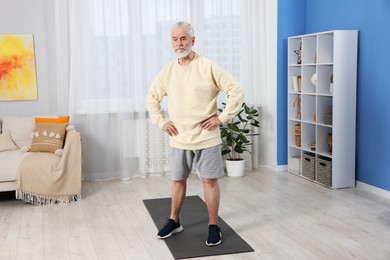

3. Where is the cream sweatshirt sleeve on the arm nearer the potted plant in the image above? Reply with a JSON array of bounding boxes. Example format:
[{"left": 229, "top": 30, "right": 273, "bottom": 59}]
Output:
[{"left": 212, "top": 64, "right": 245, "bottom": 124}]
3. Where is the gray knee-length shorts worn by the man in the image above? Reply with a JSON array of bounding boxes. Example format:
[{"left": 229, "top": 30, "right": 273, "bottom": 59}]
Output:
[{"left": 171, "top": 145, "right": 225, "bottom": 181}]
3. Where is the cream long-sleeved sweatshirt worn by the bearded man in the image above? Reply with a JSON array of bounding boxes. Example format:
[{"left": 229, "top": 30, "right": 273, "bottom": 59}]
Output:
[{"left": 146, "top": 54, "right": 244, "bottom": 150}]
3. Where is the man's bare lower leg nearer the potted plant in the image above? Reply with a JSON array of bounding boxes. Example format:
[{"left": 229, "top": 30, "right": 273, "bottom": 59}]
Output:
[{"left": 202, "top": 179, "right": 221, "bottom": 225}]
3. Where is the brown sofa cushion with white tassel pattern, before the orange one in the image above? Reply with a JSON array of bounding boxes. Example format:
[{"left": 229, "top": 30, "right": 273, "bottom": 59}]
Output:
[{"left": 29, "top": 123, "right": 68, "bottom": 153}]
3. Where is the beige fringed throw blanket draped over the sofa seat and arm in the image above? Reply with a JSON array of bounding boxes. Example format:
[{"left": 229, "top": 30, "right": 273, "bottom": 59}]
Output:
[{"left": 16, "top": 130, "right": 81, "bottom": 205}]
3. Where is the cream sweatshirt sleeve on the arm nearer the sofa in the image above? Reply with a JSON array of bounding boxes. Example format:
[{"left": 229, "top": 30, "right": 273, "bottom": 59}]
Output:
[{"left": 146, "top": 74, "right": 168, "bottom": 129}]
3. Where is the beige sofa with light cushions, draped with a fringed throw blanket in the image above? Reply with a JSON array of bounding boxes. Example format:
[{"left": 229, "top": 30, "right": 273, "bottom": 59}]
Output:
[{"left": 0, "top": 116, "right": 81, "bottom": 204}]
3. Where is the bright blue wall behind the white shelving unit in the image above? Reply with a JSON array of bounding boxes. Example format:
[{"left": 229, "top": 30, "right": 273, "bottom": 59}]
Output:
[{"left": 278, "top": 0, "right": 390, "bottom": 191}]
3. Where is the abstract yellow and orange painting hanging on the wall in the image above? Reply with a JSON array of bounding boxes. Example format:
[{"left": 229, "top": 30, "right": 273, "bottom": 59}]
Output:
[{"left": 0, "top": 34, "right": 38, "bottom": 101}]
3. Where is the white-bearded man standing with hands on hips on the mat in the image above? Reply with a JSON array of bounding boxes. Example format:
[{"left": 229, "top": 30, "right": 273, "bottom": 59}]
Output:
[{"left": 146, "top": 22, "right": 244, "bottom": 246}]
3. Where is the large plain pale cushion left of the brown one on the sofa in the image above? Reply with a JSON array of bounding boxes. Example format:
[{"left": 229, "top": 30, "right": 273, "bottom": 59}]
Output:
[{"left": 2, "top": 116, "right": 34, "bottom": 148}]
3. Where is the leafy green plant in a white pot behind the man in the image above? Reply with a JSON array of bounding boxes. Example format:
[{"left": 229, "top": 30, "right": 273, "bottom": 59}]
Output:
[{"left": 218, "top": 103, "right": 260, "bottom": 177}]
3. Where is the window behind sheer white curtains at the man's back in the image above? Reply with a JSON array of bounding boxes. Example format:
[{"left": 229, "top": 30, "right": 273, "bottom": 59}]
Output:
[{"left": 75, "top": 0, "right": 250, "bottom": 113}]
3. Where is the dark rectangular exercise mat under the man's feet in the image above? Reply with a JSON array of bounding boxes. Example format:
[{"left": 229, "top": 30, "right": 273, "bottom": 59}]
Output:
[{"left": 143, "top": 196, "right": 254, "bottom": 259}]
